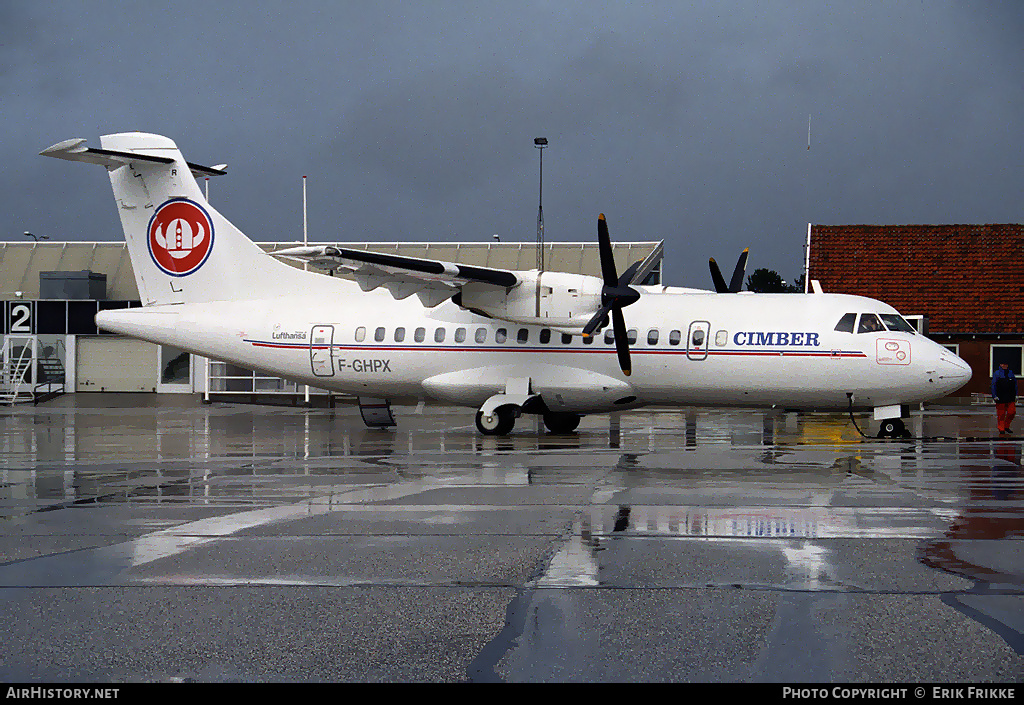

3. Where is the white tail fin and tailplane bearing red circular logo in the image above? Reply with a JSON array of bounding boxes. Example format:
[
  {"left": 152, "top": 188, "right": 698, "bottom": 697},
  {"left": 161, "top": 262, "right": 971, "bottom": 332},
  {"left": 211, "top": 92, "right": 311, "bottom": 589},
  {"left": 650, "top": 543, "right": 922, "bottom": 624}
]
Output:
[{"left": 40, "top": 132, "right": 316, "bottom": 305}]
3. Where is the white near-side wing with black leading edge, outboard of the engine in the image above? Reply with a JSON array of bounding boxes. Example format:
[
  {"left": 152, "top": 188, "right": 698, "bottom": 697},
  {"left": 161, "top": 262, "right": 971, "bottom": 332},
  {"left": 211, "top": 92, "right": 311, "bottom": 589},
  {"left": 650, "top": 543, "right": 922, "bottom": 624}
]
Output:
[{"left": 270, "top": 245, "right": 522, "bottom": 306}]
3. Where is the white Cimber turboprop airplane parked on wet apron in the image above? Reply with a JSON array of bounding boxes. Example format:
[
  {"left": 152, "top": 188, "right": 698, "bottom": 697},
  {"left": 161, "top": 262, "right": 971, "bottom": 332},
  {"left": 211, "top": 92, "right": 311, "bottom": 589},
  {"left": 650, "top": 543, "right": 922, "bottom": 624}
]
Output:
[{"left": 42, "top": 132, "right": 971, "bottom": 437}]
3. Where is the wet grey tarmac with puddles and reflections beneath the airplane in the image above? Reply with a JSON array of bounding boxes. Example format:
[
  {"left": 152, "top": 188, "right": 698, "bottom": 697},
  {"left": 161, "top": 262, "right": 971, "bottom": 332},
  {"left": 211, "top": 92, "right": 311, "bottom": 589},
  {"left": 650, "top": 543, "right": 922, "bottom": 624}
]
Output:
[{"left": 0, "top": 395, "right": 1024, "bottom": 682}]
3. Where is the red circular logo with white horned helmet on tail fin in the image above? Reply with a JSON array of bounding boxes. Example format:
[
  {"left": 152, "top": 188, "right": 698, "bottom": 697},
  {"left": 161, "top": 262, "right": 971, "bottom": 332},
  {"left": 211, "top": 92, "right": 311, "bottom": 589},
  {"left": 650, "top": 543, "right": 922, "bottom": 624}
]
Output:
[{"left": 146, "top": 199, "right": 213, "bottom": 277}]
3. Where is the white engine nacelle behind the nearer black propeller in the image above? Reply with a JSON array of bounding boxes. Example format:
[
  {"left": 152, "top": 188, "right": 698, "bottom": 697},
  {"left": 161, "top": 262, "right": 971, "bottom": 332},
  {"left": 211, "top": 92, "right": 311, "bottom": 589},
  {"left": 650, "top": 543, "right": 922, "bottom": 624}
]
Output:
[{"left": 452, "top": 269, "right": 603, "bottom": 331}]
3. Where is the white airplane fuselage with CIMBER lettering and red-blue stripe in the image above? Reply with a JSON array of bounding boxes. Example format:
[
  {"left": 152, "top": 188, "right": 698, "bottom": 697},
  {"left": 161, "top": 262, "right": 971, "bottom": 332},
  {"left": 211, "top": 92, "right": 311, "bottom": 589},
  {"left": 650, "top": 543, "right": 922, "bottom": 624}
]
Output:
[{"left": 97, "top": 282, "right": 970, "bottom": 413}]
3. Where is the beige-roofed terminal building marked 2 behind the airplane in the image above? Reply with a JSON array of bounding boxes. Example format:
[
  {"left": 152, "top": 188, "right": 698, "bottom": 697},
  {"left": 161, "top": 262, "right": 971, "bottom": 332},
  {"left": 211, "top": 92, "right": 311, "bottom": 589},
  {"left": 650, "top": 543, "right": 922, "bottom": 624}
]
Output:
[{"left": 0, "top": 241, "right": 664, "bottom": 405}]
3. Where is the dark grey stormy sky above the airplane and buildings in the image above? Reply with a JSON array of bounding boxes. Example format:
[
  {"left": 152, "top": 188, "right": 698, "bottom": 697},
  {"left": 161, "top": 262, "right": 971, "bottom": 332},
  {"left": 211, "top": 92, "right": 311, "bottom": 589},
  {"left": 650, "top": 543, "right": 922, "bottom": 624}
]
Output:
[{"left": 0, "top": 0, "right": 1024, "bottom": 287}]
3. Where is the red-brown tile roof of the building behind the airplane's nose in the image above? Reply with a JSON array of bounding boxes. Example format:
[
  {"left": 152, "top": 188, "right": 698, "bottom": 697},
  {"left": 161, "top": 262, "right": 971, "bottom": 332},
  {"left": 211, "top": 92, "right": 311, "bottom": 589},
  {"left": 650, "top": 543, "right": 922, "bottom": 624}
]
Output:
[{"left": 810, "top": 224, "right": 1024, "bottom": 333}]
